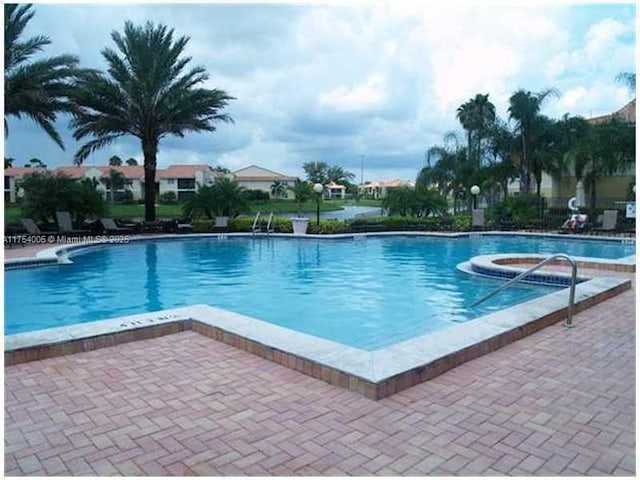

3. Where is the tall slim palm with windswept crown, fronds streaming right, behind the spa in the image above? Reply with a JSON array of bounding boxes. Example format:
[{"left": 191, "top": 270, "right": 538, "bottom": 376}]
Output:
[{"left": 509, "top": 88, "right": 558, "bottom": 193}]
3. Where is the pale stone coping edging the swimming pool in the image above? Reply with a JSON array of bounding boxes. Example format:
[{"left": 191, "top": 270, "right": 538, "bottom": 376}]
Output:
[{"left": 4, "top": 232, "right": 635, "bottom": 399}]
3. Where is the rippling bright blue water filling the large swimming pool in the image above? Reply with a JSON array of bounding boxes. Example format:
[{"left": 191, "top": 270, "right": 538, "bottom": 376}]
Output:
[{"left": 5, "top": 236, "right": 635, "bottom": 350}]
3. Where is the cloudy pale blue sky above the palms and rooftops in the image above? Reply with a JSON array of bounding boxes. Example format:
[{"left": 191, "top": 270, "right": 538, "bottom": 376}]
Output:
[{"left": 5, "top": 1, "right": 636, "bottom": 181}]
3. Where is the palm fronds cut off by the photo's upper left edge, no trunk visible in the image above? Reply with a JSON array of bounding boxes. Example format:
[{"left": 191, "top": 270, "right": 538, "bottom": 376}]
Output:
[{"left": 4, "top": 3, "right": 86, "bottom": 150}]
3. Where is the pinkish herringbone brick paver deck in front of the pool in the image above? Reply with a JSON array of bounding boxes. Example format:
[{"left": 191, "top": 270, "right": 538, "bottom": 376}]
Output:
[{"left": 5, "top": 284, "right": 635, "bottom": 475}]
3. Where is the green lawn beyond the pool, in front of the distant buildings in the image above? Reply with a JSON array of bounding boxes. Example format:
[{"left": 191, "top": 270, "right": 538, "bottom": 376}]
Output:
[{"left": 4, "top": 199, "right": 380, "bottom": 225}]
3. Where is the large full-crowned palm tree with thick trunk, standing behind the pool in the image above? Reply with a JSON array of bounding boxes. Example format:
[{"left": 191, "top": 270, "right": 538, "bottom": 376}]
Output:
[{"left": 71, "top": 22, "right": 233, "bottom": 221}]
